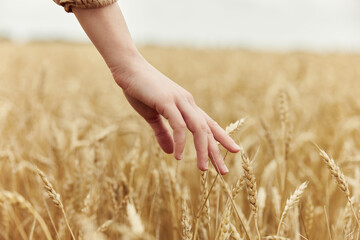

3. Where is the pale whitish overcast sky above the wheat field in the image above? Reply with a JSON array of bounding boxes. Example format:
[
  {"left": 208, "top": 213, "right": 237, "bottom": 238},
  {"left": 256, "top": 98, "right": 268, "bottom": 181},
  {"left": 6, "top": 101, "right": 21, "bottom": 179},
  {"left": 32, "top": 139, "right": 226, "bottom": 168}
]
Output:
[{"left": 0, "top": 0, "right": 360, "bottom": 52}]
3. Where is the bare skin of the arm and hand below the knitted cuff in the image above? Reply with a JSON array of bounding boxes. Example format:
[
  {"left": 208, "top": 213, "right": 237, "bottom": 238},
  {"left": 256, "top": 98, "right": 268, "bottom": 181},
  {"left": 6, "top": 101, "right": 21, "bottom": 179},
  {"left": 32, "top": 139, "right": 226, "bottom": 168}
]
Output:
[{"left": 72, "top": 1, "right": 240, "bottom": 174}]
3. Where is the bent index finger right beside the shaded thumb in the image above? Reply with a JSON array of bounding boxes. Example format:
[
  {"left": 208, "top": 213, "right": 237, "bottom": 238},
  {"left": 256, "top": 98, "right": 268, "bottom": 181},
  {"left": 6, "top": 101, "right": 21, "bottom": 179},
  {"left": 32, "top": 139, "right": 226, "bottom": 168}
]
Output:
[{"left": 163, "top": 106, "right": 186, "bottom": 160}]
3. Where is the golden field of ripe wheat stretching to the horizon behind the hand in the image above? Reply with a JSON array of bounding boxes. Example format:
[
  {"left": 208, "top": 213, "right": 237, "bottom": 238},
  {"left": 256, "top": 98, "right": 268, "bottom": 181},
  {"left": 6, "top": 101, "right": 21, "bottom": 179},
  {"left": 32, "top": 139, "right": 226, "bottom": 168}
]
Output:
[{"left": 0, "top": 41, "right": 360, "bottom": 240}]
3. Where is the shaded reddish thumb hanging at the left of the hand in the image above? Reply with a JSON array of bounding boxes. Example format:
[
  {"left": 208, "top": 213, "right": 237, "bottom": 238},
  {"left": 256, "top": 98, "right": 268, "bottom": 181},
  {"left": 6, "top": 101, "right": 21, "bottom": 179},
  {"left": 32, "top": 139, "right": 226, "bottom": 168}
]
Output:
[{"left": 146, "top": 115, "right": 174, "bottom": 153}]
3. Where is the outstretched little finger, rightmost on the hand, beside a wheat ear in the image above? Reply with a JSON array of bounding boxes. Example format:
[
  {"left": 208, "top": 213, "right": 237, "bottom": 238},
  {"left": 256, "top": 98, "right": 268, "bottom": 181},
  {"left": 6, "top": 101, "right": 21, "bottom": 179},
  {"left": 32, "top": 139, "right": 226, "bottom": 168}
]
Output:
[{"left": 199, "top": 108, "right": 240, "bottom": 153}]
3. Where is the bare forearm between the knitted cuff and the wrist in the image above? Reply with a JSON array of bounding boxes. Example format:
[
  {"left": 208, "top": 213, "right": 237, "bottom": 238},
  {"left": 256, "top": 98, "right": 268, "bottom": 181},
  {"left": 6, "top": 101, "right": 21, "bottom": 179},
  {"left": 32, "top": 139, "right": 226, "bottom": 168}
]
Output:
[{"left": 72, "top": 3, "right": 142, "bottom": 82}]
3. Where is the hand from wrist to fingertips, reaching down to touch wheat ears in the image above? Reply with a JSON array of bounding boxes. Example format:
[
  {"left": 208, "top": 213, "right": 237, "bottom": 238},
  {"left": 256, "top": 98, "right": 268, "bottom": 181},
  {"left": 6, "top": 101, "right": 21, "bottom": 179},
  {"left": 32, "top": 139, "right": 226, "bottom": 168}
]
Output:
[{"left": 111, "top": 55, "right": 239, "bottom": 174}]
